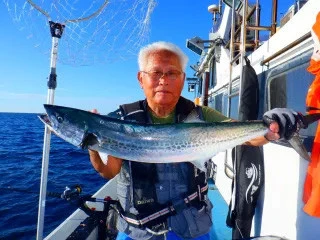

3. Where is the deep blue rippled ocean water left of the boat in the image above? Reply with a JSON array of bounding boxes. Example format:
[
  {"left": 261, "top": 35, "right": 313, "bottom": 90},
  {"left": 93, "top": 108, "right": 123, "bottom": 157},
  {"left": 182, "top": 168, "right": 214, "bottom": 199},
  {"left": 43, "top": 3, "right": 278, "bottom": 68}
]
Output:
[{"left": 0, "top": 113, "right": 106, "bottom": 240}]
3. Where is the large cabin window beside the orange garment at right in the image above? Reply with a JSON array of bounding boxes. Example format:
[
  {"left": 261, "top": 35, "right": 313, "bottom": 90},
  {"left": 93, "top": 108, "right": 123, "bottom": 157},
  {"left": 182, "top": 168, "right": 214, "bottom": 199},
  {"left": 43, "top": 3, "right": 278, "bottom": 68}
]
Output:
[{"left": 268, "top": 55, "right": 316, "bottom": 136}]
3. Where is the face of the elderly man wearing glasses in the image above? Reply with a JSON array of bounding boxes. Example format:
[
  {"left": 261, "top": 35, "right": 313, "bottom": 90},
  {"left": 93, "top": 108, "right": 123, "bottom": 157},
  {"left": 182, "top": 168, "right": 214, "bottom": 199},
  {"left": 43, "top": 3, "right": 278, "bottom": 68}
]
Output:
[{"left": 138, "top": 50, "right": 185, "bottom": 107}]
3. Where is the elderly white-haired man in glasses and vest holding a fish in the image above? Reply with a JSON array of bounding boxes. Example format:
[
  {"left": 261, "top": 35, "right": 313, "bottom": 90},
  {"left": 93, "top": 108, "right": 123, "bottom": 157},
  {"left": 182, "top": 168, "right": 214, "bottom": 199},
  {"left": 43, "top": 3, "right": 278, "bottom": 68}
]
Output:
[{"left": 89, "top": 42, "right": 296, "bottom": 239}]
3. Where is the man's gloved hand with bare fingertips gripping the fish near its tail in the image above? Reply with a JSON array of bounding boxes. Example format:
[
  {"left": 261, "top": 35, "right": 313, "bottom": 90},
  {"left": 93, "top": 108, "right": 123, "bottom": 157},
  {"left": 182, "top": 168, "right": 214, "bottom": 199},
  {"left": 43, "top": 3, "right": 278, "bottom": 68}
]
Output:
[{"left": 263, "top": 108, "right": 299, "bottom": 141}]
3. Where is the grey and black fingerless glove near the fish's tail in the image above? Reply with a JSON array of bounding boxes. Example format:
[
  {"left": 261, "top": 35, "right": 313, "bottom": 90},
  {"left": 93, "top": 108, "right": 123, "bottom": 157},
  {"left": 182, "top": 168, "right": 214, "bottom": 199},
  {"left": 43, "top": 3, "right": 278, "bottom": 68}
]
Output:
[{"left": 263, "top": 108, "right": 300, "bottom": 140}]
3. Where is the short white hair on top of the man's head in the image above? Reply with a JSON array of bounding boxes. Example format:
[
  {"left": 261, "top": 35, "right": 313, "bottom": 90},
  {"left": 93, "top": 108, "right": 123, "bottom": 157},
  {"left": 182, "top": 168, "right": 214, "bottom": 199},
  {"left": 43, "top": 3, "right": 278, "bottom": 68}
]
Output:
[{"left": 138, "top": 41, "right": 188, "bottom": 71}]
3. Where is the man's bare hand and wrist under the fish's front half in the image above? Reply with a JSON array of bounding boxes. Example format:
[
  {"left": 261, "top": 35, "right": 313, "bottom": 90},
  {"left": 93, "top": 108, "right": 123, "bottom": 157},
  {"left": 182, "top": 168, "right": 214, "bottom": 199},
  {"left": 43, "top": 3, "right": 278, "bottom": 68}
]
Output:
[{"left": 89, "top": 150, "right": 122, "bottom": 179}]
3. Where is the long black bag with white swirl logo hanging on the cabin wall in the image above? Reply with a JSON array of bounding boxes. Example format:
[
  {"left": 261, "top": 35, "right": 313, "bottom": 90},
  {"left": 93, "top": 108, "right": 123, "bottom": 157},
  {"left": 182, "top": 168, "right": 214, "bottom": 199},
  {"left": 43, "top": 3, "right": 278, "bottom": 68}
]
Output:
[{"left": 226, "top": 57, "right": 265, "bottom": 239}]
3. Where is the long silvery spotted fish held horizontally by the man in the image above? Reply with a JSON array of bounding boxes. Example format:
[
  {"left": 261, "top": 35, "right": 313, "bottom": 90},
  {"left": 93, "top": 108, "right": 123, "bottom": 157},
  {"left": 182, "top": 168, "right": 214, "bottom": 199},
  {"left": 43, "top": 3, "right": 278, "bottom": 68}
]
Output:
[{"left": 40, "top": 105, "right": 316, "bottom": 169}]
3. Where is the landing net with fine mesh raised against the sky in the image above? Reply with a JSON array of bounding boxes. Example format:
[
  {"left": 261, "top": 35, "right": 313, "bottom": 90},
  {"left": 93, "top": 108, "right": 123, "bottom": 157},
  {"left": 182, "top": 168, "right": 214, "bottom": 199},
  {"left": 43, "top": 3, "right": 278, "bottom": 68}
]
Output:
[{"left": 3, "top": 0, "right": 156, "bottom": 66}]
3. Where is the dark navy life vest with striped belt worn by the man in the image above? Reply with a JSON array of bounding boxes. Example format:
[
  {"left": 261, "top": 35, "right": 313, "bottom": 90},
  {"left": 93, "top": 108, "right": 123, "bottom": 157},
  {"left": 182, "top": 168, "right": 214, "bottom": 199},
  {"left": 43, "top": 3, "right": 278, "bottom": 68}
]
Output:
[{"left": 117, "top": 97, "right": 208, "bottom": 235}]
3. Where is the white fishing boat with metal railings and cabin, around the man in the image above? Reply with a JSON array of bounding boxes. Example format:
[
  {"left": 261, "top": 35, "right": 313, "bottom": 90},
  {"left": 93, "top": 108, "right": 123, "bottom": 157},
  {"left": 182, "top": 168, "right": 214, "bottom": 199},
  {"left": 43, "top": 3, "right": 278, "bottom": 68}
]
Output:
[{"left": 45, "top": 0, "right": 320, "bottom": 240}]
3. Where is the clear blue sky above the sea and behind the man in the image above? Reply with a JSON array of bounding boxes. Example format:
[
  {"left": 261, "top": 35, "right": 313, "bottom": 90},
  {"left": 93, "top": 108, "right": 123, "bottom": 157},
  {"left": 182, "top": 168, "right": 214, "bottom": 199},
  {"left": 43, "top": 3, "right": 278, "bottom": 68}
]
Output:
[{"left": 0, "top": 0, "right": 294, "bottom": 114}]
